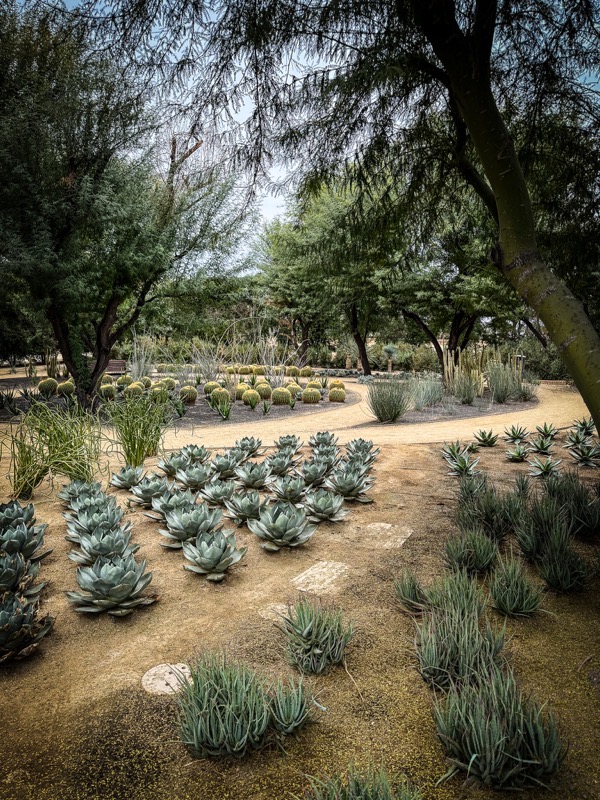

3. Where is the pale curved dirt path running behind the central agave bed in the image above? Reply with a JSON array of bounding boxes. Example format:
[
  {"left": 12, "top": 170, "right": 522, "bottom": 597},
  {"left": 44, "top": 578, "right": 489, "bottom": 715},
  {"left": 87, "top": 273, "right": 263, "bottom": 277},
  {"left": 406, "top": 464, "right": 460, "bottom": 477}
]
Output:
[{"left": 165, "top": 382, "right": 589, "bottom": 449}]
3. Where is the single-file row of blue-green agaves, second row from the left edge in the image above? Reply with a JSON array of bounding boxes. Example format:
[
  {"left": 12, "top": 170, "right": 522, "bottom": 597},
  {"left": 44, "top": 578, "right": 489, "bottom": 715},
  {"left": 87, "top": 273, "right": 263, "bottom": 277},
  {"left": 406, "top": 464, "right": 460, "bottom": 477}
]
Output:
[{"left": 58, "top": 481, "right": 157, "bottom": 617}]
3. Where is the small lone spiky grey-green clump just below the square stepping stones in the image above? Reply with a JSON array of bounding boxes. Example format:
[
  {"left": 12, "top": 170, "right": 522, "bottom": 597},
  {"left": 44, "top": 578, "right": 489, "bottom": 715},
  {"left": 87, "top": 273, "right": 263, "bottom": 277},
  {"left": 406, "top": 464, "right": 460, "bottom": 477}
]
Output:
[{"left": 281, "top": 597, "right": 354, "bottom": 675}]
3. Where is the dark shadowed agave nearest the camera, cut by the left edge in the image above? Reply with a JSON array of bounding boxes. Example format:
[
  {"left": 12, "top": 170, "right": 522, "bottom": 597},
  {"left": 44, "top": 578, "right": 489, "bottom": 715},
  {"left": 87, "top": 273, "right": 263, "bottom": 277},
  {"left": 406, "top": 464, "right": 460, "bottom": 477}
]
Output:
[{"left": 0, "top": 592, "right": 54, "bottom": 664}]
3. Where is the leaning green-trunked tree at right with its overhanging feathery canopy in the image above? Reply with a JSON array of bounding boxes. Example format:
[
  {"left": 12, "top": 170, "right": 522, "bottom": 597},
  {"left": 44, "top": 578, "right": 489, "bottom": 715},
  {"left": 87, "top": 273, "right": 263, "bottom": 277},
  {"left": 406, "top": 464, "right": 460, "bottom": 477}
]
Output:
[{"left": 96, "top": 0, "right": 600, "bottom": 426}]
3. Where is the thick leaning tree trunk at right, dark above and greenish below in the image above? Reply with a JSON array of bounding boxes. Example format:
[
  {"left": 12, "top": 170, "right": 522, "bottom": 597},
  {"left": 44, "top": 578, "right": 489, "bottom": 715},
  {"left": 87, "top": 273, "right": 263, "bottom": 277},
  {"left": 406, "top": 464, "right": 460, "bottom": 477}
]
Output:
[{"left": 413, "top": 0, "right": 600, "bottom": 430}]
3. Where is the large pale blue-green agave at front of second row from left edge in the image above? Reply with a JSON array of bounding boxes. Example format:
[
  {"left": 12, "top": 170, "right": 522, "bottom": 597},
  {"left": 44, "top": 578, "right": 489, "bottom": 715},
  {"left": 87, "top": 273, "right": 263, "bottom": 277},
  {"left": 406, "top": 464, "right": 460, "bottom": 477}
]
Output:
[{"left": 67, "top": 555, "right": 158, "bottom": 617}]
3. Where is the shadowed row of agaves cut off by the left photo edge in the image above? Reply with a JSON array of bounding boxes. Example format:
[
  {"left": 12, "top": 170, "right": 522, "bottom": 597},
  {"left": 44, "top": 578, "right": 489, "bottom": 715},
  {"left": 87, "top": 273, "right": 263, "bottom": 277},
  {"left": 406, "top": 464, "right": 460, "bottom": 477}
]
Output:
[{"left": 0, "top": 500, "right": 54, "bottom": 663}]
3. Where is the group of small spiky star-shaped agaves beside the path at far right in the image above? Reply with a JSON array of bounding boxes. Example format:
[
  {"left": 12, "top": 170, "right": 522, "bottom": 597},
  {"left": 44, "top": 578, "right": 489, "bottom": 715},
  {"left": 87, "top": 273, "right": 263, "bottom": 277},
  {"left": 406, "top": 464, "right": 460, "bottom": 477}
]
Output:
[{"left": 442, "top": 418, "right": 600, "bottom": 478}]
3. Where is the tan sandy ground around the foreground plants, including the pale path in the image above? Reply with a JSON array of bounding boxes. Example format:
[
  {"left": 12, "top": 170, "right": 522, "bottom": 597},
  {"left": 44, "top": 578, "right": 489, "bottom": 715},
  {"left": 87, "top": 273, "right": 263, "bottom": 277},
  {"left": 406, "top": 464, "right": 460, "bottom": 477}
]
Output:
[{"left": 0, "top": 386, "right": 600, "bottom": 800}]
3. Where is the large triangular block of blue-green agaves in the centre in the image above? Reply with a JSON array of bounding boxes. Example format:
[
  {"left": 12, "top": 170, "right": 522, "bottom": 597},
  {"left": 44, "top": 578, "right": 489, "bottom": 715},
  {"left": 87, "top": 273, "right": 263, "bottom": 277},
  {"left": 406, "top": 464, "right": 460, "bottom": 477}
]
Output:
[{"left": 111, "top": 432, "right": 379, "bottom": 581}]
